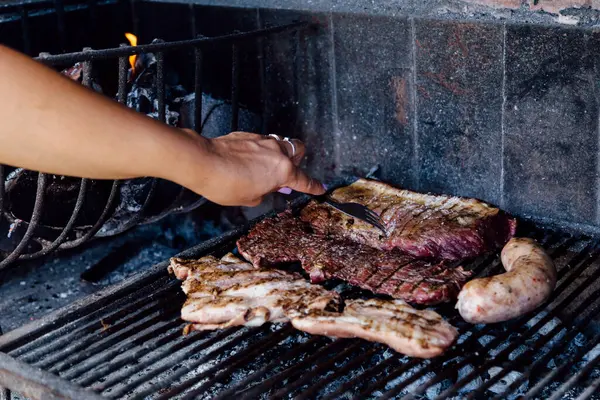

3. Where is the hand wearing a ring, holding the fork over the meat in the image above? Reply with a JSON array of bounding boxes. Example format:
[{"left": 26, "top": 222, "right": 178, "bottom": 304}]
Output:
[{"left": 180, "top": 131, "right": 325, "bottom": 206}]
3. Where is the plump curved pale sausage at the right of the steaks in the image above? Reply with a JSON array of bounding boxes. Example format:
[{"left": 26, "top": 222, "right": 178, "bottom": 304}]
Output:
[{"left": 456, "top": 238, "right": 556, "bottom": 324}]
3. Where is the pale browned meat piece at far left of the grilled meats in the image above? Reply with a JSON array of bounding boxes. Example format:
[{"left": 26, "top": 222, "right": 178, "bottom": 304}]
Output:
[{"left": 169, "top": 254, "right": 339, "bottom": 330}]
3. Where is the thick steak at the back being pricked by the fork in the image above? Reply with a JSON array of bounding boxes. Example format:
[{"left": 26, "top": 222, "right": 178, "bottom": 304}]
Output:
[{"left": 301, "top": 179, "right": 516, "bottom": 260}]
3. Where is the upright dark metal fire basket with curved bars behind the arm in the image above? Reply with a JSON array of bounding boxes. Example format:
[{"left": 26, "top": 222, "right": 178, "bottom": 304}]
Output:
[{"left": 0, "top": 0, "right": 307, "bottom": 270}]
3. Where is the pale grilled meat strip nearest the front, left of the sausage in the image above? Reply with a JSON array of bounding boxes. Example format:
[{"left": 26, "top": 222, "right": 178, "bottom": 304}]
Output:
[{"left": 292, "top": 299, "right": 458, "bottom": 358}]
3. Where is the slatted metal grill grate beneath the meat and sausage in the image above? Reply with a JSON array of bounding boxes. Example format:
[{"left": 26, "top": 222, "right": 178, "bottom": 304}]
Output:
[{"left": 0, "top": 209, "right": 600, "bottom": 399}]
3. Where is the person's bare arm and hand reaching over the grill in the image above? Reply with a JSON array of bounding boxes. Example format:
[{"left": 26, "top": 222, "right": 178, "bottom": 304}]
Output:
[{"left": 0, "top": 46, "right": 323, "bottom": 205}]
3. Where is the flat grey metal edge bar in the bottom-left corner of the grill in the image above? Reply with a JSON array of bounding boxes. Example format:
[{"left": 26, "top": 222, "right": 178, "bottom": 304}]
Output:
[{"left": 0, "top": 352, "right": 106, "bottom": 400}]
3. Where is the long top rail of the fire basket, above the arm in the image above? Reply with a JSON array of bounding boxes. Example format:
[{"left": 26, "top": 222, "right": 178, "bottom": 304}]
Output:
[{"left": 35, "top": 22, "right": 308, "bottom": 65}]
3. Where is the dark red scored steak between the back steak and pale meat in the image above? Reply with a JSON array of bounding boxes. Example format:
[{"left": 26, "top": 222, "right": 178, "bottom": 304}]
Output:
[{"left": 237, "top": 211, "right": 470, "bottom": 305}]
